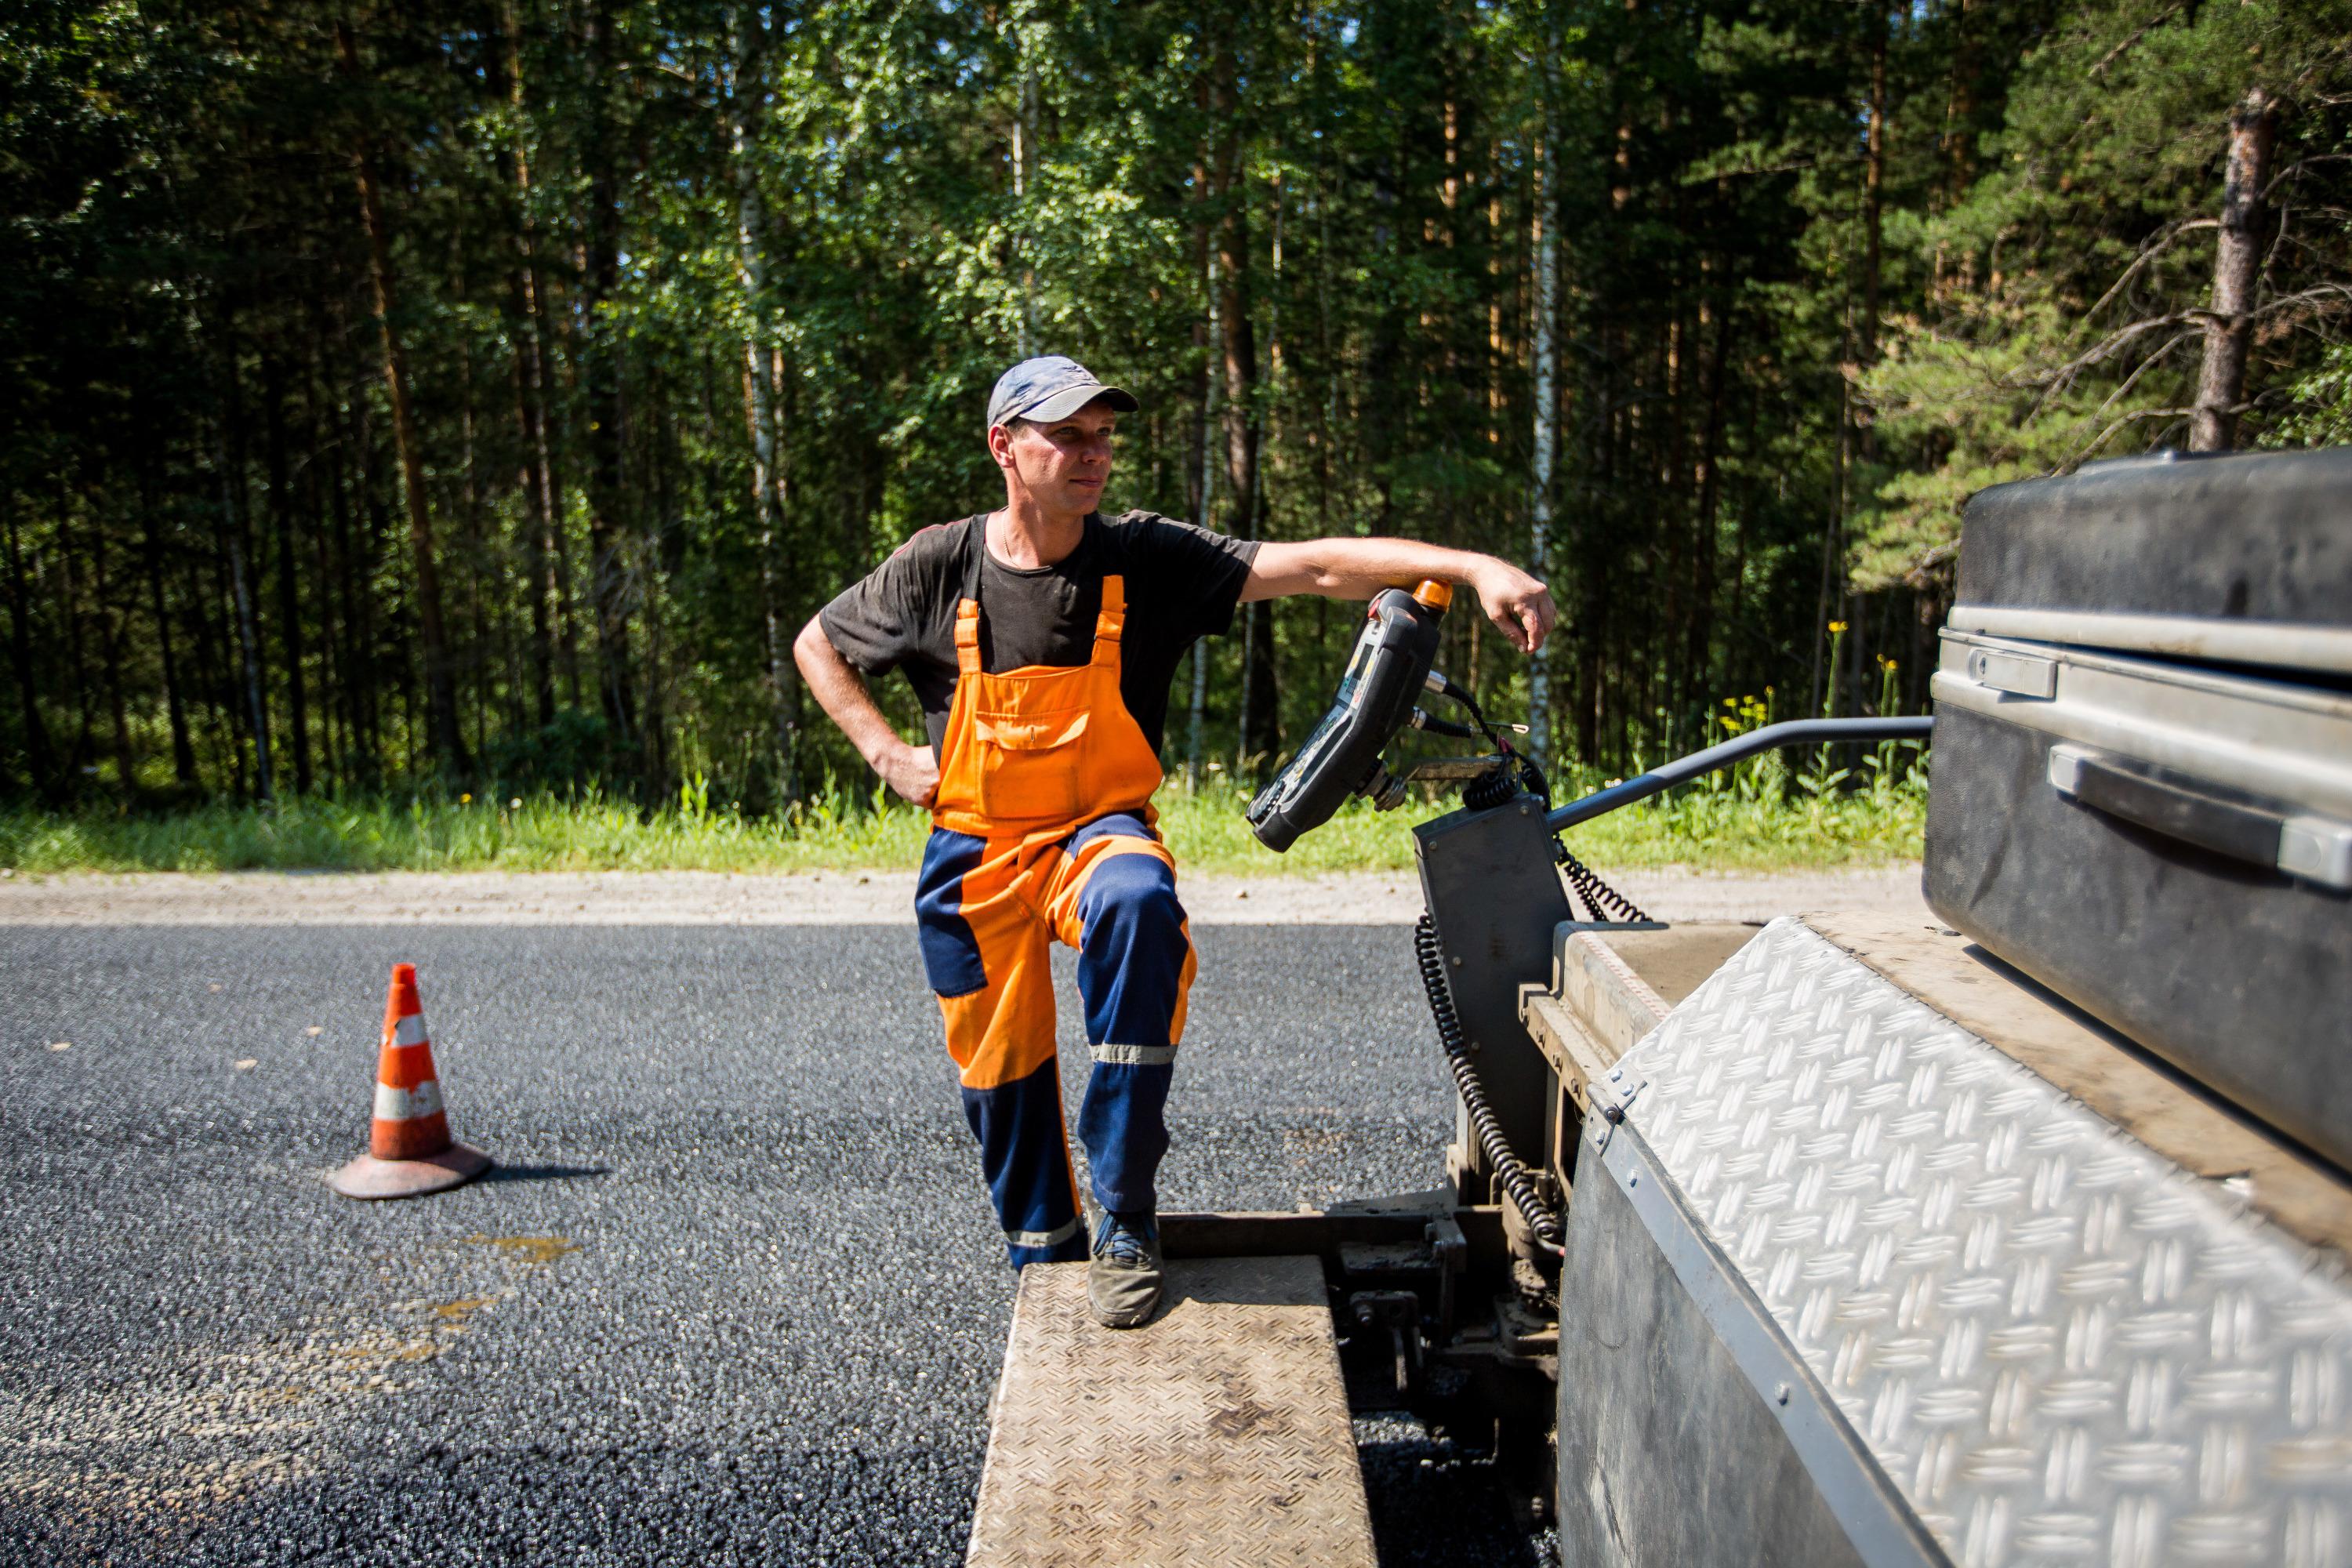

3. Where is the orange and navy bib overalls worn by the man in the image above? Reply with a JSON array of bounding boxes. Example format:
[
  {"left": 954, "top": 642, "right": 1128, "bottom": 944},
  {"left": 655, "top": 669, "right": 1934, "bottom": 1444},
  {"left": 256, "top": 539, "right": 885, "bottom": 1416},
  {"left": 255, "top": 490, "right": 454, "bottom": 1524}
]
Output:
[{"left": 915, "top": 535, "right": 1195, "bottom": 1267}]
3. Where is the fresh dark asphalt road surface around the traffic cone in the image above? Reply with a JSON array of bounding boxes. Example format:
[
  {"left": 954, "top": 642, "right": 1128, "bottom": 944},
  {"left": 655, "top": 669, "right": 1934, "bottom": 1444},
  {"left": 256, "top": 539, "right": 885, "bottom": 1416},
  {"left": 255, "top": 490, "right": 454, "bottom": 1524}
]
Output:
[{"left": 0, "top": 926, "right": 1548, "bottom": 1566}]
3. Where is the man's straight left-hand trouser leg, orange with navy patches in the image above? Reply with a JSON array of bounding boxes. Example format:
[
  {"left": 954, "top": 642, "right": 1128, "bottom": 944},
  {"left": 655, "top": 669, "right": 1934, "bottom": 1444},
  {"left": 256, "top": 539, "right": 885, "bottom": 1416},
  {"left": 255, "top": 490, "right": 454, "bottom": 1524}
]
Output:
[{"left": 915, "top": 829, "right": 1087, "bottom": 1269}]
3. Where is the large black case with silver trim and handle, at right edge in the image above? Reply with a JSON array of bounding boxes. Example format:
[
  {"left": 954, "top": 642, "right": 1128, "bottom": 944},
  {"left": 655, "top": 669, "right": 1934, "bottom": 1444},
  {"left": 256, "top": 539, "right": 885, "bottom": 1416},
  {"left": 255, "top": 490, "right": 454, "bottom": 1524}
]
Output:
[{"left": 1926, "top": 452, "right": 2352, "bottom": 1163}]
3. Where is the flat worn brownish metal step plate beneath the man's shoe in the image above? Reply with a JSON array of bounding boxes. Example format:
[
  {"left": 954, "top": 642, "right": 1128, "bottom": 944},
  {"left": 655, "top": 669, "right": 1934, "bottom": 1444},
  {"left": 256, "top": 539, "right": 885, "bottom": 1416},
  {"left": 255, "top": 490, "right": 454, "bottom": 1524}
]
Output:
[{"left": 967, "top": 1258, "right": 1374, "bottom": 1568}]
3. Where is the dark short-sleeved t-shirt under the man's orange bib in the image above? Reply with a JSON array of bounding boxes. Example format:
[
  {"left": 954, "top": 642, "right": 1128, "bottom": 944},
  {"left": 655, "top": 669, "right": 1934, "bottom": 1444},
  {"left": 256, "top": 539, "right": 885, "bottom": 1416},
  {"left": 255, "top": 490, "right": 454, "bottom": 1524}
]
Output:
[{"left": 818, "top": 513, "right": 1258, "bottom": 753}]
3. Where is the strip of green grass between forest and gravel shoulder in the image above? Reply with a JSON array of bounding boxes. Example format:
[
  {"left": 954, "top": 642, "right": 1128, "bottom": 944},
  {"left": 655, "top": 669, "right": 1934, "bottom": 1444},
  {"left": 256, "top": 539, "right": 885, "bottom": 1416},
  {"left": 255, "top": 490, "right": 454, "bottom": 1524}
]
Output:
[{"left": 0, "top": 748, "right": 1926, "bottom": 874}]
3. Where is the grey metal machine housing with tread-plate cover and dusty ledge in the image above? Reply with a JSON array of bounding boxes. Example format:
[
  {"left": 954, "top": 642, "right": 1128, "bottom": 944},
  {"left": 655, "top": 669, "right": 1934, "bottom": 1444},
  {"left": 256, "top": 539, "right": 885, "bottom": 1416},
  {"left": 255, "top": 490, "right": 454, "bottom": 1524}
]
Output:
[{"left": 1559, "top": 921, "right": 2352, "bottom": 1568}]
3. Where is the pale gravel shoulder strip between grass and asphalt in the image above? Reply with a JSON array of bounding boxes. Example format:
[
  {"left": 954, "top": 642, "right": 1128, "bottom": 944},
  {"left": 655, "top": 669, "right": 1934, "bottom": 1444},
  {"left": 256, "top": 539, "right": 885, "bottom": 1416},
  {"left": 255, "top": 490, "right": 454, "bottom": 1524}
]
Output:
[{"left": 0, "top": 862, "right": 1929, "bottom": 926}]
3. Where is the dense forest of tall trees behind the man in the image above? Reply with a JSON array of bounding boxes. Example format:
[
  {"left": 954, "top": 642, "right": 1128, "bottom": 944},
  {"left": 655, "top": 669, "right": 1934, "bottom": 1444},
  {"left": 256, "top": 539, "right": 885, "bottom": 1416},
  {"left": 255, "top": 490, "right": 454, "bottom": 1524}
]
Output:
[{"left": 0, "top": 0, "right": 2352, "bottom": 813}]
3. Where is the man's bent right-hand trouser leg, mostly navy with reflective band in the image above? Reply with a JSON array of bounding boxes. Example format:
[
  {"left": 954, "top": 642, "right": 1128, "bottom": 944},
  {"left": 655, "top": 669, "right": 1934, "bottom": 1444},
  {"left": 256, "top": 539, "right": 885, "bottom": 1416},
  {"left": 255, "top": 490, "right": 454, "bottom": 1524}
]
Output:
[{"left": 1056, "top": 818, "right": 1195, "bottom": 1210}]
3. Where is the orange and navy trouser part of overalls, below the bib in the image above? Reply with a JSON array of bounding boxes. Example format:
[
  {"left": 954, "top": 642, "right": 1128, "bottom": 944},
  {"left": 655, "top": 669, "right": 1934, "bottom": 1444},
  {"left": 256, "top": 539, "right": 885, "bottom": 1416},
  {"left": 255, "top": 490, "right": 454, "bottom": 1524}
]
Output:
[{"left": 915, "top": 811, "right": 1195, "bottom": 1269}]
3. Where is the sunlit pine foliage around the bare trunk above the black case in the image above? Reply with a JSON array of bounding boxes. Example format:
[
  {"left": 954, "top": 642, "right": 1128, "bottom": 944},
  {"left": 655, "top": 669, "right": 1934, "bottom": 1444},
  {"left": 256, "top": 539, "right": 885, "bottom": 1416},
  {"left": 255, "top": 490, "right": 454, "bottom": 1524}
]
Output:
[{"left": 1853, "top": 0, "right": 2352, "bottom": 586}]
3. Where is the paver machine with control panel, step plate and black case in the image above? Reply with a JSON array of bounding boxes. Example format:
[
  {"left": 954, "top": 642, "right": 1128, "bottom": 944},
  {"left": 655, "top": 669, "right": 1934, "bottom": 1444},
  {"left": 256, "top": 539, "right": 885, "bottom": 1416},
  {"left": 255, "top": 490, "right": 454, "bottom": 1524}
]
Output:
[{"left": 971, "top": 449, "right": 2352, "bottom": 1568}]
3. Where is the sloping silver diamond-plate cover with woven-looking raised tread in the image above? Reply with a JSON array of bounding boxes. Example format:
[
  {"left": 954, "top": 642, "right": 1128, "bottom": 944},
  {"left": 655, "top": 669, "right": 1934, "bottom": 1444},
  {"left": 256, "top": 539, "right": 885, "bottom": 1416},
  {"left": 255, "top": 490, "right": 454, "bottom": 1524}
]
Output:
[{"left": 1585, "top": 919, "right": 2352, "bottom": 1568}]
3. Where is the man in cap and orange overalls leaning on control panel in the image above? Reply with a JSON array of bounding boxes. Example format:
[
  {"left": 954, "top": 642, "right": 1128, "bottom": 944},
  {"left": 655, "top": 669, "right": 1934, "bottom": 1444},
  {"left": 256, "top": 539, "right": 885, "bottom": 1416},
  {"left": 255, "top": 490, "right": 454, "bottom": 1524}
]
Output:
[{"left": 793, "top": 355, "right": 1555, "bottom": 1328}]
